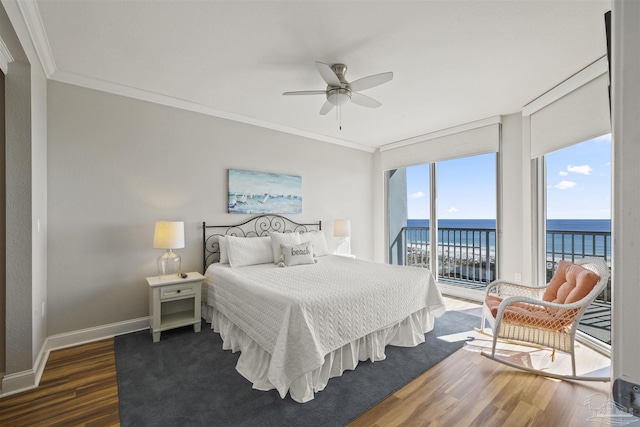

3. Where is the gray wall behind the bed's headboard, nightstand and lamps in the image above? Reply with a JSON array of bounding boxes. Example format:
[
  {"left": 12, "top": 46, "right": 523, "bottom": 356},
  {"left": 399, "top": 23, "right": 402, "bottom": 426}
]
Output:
[{"left": 48, "top": 81, "right": 374, "bottom": 335}]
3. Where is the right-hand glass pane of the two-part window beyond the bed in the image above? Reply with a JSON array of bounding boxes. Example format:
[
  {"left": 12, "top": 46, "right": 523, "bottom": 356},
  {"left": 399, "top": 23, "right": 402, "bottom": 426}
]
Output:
[{"left": 436, "top": 153, "right": 496, "bottom": 289}]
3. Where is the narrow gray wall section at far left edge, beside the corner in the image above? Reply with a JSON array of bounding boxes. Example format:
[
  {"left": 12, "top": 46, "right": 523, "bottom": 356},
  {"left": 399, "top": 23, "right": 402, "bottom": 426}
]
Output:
[{"left": 0, "top": 2, "right": 47, "bottom": 382}]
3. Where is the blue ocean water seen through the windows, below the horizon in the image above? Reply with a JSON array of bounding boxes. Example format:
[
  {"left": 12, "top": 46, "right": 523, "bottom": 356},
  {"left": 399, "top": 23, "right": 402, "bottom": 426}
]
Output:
[{"left": 407, "top": 219, "right": 611, "bottom": 261}]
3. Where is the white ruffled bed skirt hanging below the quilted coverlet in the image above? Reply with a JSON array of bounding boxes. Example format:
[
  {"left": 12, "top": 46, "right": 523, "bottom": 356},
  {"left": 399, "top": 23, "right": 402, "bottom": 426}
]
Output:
[{"left": 202, "top": 303, "right": 445, "bottom": 403}]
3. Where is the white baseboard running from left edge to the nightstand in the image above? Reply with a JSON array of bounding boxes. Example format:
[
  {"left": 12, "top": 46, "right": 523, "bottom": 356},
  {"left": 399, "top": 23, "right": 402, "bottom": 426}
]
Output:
[{"left": 0, "top": 317, "right": 149, "bottom": 397}]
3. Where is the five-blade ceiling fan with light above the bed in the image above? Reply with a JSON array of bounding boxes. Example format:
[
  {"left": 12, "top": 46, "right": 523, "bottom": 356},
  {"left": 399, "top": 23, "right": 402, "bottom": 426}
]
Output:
[{"left": 283, "top": 61, "right": 393, "bottom": 115}]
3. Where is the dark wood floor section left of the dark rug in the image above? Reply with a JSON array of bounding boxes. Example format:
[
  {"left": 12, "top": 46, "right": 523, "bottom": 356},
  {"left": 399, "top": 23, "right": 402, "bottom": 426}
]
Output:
[{"left": 0, "top": 339, "right": 120, "bottom": 427}]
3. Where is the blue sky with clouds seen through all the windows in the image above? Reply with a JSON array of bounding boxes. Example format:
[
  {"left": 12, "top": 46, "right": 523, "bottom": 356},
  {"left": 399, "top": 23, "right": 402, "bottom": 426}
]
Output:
[{"left": 407, "top": 135, "right": 611, "bottom": 219}]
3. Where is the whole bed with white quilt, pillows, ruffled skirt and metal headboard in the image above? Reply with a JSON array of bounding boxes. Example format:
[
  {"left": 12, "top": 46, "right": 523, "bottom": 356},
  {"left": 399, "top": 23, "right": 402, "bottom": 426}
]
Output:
[{"left": 202, "top": 215, "right": 445, "bottom": 403}]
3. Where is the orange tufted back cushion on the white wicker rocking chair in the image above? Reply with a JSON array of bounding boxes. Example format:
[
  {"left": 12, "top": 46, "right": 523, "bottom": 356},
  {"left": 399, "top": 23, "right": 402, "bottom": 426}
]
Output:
[{"left": 542, "top": 260, "right": 600, "bottom": 304}]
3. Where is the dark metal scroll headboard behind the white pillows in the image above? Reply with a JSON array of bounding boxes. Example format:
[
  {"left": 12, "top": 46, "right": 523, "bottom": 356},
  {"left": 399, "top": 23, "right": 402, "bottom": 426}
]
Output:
[{"left": 202, "top": 215, "right": 322, "bottom": 273}]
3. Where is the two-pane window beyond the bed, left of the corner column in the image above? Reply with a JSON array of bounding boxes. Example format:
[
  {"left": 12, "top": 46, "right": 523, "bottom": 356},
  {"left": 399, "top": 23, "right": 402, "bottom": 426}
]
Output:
[{"left": 387, "top": 153, "right": 497, "bottom": 296}]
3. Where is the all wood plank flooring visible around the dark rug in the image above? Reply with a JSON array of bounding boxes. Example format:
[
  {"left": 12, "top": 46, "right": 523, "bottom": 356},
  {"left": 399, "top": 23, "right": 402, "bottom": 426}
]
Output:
[{"left": 0, "top": 328, "right": 611, "bottom": 427}]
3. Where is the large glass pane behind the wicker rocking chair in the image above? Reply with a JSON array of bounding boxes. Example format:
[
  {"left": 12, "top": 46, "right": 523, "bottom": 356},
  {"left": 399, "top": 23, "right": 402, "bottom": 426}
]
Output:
[{"left": 545, "top": 135, "right": 611, "bottom": 344}]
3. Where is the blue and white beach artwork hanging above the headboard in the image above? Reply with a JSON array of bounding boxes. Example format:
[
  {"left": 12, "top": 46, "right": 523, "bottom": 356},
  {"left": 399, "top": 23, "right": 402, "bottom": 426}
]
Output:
[{"left": 227, "top": 169, "right": 302, "bottom": 214}]
